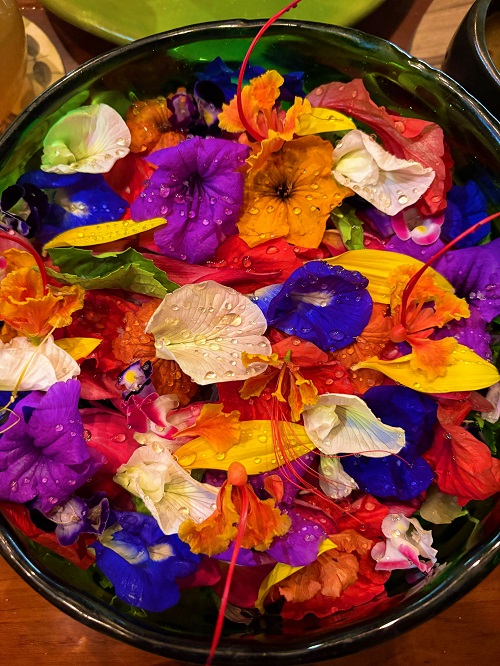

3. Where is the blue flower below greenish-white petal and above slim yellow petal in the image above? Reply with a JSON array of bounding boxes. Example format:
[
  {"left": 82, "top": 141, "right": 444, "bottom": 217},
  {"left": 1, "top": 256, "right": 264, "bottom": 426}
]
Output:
[{"left": 18, "top": 171, "right": 128, "bottom": 243}]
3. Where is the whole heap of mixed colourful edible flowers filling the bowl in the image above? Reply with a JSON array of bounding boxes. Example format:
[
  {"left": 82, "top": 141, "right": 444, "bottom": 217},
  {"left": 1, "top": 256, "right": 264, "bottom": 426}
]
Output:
[{"left": 0, "top": 2, "right": 500, "bottom": 659}]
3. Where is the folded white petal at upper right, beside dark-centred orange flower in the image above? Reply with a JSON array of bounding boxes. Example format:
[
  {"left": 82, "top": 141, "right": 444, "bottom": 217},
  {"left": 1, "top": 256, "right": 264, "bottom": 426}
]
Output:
[{"left": 332, "top": 130, "right": 435, "bottom": 215}]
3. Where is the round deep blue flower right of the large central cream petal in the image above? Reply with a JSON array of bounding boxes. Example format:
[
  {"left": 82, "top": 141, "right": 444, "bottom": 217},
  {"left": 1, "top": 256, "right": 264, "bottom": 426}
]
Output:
[{"left": 257, "top": 261, "right": 373, "bottom": 351}]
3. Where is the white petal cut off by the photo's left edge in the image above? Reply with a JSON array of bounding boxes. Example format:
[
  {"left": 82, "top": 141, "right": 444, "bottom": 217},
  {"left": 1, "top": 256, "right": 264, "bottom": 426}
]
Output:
[{"left": 0, "top": 336, "right": 80, "bottom": 391}]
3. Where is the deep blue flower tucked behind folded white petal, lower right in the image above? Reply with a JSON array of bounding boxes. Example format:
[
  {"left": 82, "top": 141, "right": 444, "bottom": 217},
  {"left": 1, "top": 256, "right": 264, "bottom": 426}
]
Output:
[{"left": 342, "top": 386, "right": 437, "bottom": 500}]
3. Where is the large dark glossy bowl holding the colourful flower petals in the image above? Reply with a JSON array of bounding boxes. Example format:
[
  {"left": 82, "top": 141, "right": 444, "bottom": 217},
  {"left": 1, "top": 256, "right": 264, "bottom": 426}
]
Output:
[{"left": 0, "top": 20, "right": 500, "bottom": 666}]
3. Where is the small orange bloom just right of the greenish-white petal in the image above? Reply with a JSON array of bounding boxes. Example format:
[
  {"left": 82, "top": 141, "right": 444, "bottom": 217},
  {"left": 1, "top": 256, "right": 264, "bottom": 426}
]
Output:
[{"left": 126, "top": 97, "right": 184, "bottom": 153}]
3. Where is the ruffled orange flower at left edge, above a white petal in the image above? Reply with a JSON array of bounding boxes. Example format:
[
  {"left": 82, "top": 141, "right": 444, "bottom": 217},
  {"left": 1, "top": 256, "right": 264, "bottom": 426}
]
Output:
[{"left": 0, "top": 249, "right": 85, "bottom": 338}]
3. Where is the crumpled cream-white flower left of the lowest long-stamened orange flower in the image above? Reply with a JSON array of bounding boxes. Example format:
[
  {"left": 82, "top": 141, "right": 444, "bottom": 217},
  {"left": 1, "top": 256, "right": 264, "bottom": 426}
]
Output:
[{"left": 115, "top": 444, "right": 219, "bottom": 534}]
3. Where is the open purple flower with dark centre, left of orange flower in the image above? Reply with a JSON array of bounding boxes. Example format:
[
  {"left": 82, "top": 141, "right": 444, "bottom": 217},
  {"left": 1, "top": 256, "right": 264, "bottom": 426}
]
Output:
[{"left": 131, "top": 137, "right": 248, "bottom": 264}]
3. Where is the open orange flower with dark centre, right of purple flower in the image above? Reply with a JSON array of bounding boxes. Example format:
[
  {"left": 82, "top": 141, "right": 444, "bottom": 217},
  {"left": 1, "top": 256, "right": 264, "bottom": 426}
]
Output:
[{"left": 238, "top": 136, "right": 352, "bottom": 248}]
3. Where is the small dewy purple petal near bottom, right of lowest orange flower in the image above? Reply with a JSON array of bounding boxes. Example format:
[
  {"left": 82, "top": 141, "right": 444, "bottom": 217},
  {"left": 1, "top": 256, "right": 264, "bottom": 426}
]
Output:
[{"left": 267, "top": 510, "right": 327, "bottom": 567}]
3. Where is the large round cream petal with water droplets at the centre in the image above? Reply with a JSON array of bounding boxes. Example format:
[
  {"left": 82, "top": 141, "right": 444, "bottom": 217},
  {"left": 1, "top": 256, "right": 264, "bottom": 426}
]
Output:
[{"left": 146, "top": 280, "right": 271, "bottom": 385}]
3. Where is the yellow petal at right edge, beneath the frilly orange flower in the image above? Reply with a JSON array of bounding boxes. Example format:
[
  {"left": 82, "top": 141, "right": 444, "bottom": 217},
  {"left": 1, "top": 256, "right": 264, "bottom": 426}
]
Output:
[{"left": 353, "top": 345, "right": 500, "bottom": 393}]
